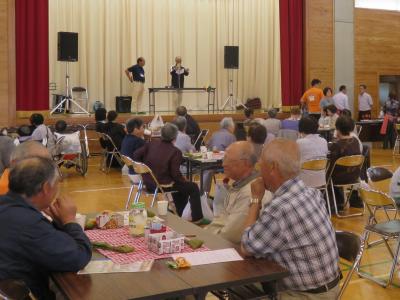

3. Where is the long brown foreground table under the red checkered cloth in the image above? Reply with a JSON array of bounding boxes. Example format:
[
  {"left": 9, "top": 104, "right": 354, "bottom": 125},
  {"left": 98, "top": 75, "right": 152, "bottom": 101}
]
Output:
[{"left": 52, "top": 214, "right": 289, "bottom": 300}]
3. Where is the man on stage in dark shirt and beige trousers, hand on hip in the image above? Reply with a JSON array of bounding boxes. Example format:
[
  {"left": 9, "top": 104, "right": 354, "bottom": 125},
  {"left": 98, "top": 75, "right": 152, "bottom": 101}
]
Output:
[{"left": 125, "top": 57, "right": 145, "bottom": 113}]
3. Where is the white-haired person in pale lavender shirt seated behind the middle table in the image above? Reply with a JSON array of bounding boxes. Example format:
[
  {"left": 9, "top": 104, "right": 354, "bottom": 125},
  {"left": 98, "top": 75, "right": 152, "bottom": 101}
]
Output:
[{"left": 203, "top": 118, "right": 236, "bottom": 193}]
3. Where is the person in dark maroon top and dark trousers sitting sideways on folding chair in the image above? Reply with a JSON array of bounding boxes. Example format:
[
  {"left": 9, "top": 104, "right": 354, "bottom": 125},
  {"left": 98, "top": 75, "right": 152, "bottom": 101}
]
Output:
[{"left": 133, "top": 123, "right": 203, "bottom": 223}]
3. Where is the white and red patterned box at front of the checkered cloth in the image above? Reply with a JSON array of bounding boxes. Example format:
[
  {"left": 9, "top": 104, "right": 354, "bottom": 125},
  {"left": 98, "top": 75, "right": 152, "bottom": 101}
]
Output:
[{"left": 147, "top": 231, "right": 185, "bottom": 255}]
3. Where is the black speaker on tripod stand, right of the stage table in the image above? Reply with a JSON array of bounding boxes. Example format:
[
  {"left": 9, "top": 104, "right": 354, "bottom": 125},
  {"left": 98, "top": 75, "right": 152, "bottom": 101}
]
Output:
[{"left": 221, "top": 46, "right": 246, "bottom": 111}]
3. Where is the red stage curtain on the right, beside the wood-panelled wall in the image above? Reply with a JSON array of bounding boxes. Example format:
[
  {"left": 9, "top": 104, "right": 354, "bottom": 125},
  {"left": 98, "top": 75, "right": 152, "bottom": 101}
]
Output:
[{"left": 279, "top": 0, "right": 303, "bottom": 106}]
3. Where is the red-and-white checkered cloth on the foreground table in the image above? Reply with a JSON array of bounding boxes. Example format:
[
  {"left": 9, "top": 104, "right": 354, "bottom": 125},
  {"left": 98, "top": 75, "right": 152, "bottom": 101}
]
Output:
[{"left": 85, "top": 227, "right": 209, "bottom": 264}]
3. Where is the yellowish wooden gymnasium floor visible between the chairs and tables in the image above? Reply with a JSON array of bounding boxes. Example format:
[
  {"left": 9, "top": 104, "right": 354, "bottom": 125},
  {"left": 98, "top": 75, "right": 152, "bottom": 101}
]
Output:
[{"left": 61, "top": 149, "right": 400, "bottom": 300}]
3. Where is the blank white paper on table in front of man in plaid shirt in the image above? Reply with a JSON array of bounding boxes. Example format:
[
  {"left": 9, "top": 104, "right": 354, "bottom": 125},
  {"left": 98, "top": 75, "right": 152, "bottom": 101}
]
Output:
[{"left": 172, "top": 248, "right": 243, "bottom": 266}]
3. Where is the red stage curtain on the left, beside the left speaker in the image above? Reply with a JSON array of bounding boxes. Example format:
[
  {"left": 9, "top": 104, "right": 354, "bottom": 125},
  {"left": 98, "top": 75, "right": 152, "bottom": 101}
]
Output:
[{"left": 15, "top": 0, "right": 49, "bottom": 111}]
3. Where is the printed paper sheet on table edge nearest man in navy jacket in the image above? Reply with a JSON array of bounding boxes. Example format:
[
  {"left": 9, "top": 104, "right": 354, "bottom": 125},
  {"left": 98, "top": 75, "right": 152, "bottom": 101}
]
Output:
[{"left": 78, "top": 260, "right": 154, "bottom": 275}]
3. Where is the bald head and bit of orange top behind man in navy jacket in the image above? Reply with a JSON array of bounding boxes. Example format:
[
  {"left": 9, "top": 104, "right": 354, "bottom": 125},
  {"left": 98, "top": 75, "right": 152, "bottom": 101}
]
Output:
[{"left": 0, "top": 141, "right": 51, "bottom": 195}]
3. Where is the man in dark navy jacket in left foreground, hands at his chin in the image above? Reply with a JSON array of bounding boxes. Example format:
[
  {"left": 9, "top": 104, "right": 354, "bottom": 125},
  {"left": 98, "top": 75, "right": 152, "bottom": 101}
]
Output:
[{"left": 0, "top": 157, "right": 92, "bottom": 299}]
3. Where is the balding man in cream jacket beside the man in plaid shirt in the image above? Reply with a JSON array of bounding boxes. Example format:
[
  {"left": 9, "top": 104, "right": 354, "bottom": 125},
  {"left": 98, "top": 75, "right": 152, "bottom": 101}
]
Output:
[{"left": 206, "top": 141, "right": 265, "bottom": 243}]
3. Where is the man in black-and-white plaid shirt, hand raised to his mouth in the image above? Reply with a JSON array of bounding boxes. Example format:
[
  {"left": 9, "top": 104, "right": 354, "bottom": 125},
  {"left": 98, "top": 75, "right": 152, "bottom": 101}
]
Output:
[{"left": 242, "top": 139, "right": 340, "bottom": 300}]
